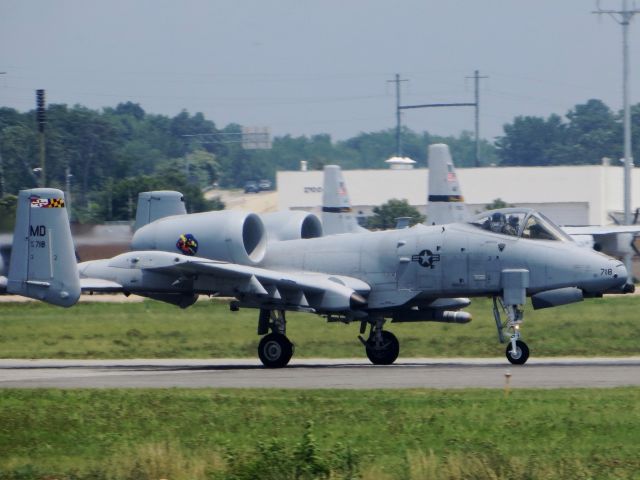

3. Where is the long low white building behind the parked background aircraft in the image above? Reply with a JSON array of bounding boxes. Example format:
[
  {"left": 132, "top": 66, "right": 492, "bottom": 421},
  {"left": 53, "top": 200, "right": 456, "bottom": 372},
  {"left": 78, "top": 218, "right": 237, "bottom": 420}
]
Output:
[{"left": 277, "top": 165, "right": 640, "bottom": 225}]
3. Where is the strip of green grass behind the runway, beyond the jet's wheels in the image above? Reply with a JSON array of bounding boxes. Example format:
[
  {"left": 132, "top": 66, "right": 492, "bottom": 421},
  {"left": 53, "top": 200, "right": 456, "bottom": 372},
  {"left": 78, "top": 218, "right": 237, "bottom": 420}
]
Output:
[{"left": 0, "top": 296, "right": 640, "bottom": 358}]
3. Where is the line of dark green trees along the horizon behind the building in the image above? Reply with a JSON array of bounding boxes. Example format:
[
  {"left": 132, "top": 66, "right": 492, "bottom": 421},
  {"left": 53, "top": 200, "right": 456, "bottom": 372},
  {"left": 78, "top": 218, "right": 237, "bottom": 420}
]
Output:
[{"left": 0, "top": 99, "right": 640, "bottom": 226}]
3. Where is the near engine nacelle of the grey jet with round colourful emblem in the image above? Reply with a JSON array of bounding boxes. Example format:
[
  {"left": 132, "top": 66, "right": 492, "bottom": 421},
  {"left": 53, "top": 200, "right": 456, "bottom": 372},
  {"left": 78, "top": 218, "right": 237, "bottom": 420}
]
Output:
[{"left": 131, "top": 210, "right": 267, "bottom": 265}]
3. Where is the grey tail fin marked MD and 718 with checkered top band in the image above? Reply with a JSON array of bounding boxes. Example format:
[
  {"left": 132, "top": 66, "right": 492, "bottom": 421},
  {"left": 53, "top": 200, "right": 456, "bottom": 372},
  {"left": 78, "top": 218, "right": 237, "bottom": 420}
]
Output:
[{"left": 7, "top": 188, "right": 80, "bottom": 307}]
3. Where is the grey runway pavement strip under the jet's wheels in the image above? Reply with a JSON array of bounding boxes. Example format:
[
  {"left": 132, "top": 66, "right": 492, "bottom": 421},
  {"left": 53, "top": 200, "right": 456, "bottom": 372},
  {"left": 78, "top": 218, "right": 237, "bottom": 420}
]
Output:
[{"left": 0, "top": 357, "right": 640, "bottom": 389}]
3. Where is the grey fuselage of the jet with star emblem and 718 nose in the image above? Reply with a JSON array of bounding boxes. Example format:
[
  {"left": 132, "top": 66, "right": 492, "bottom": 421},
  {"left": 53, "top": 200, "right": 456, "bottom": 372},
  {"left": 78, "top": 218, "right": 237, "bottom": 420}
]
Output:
[{"left": 260, "top": 224, "right": 626, "bottom": 309}]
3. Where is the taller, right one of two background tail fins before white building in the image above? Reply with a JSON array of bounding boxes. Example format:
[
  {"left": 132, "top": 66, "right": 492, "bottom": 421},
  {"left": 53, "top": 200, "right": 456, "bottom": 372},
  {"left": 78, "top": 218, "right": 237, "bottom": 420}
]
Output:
[{"left": 426, "top": 143, "right": 467, "bottom": 225}]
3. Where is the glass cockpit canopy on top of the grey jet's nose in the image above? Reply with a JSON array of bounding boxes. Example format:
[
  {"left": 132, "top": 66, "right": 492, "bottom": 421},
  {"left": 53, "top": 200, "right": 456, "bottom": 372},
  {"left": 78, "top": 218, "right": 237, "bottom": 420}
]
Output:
[{"left": 469, "top": 208, "right": 573, "bottom": 242}]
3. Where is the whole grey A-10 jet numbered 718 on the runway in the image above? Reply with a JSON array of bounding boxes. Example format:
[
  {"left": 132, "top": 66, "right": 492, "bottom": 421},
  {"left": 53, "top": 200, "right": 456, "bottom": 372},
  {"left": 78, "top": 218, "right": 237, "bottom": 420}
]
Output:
[{"left": 7, "top": 189, "right": 627, "bottom": 367}]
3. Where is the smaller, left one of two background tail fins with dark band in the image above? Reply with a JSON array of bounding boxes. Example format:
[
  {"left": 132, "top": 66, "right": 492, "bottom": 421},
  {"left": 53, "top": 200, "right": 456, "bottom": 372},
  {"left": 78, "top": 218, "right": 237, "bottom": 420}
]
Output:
[{"left": 322, "top": 165, "right": 366, "bottom": 235}]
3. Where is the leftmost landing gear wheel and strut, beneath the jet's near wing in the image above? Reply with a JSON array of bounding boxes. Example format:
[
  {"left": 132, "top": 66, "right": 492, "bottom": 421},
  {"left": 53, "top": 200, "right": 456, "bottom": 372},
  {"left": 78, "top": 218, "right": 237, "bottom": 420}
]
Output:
[{"left": 258, "top": 309, "right": 293, "bottom": 368}]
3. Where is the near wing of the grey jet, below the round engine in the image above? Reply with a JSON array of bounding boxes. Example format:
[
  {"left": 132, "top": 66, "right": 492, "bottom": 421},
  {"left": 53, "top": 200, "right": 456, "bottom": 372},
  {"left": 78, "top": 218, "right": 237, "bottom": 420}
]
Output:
[{"left": 79, "top": 251, "right": 370, "bottom": 312}]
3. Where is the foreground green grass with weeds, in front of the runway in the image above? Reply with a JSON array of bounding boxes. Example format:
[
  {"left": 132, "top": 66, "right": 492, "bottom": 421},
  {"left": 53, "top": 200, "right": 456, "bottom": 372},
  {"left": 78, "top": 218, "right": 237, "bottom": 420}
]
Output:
[{"left": 0, "top": 388, "right": 640, "bottom": 480}]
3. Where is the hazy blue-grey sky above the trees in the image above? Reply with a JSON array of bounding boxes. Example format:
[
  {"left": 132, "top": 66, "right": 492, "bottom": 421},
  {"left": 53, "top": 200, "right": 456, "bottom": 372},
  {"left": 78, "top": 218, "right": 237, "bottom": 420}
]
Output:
[{"left": 0, "top": 0, "right": 640, "bottom": 140}]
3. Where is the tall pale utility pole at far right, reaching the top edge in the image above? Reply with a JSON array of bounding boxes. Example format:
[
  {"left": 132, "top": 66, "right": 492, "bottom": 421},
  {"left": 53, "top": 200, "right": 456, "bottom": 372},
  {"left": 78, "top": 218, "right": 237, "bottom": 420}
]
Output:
[{"left": 591, "top": 0, "right": 640, "bottom": 283}]
